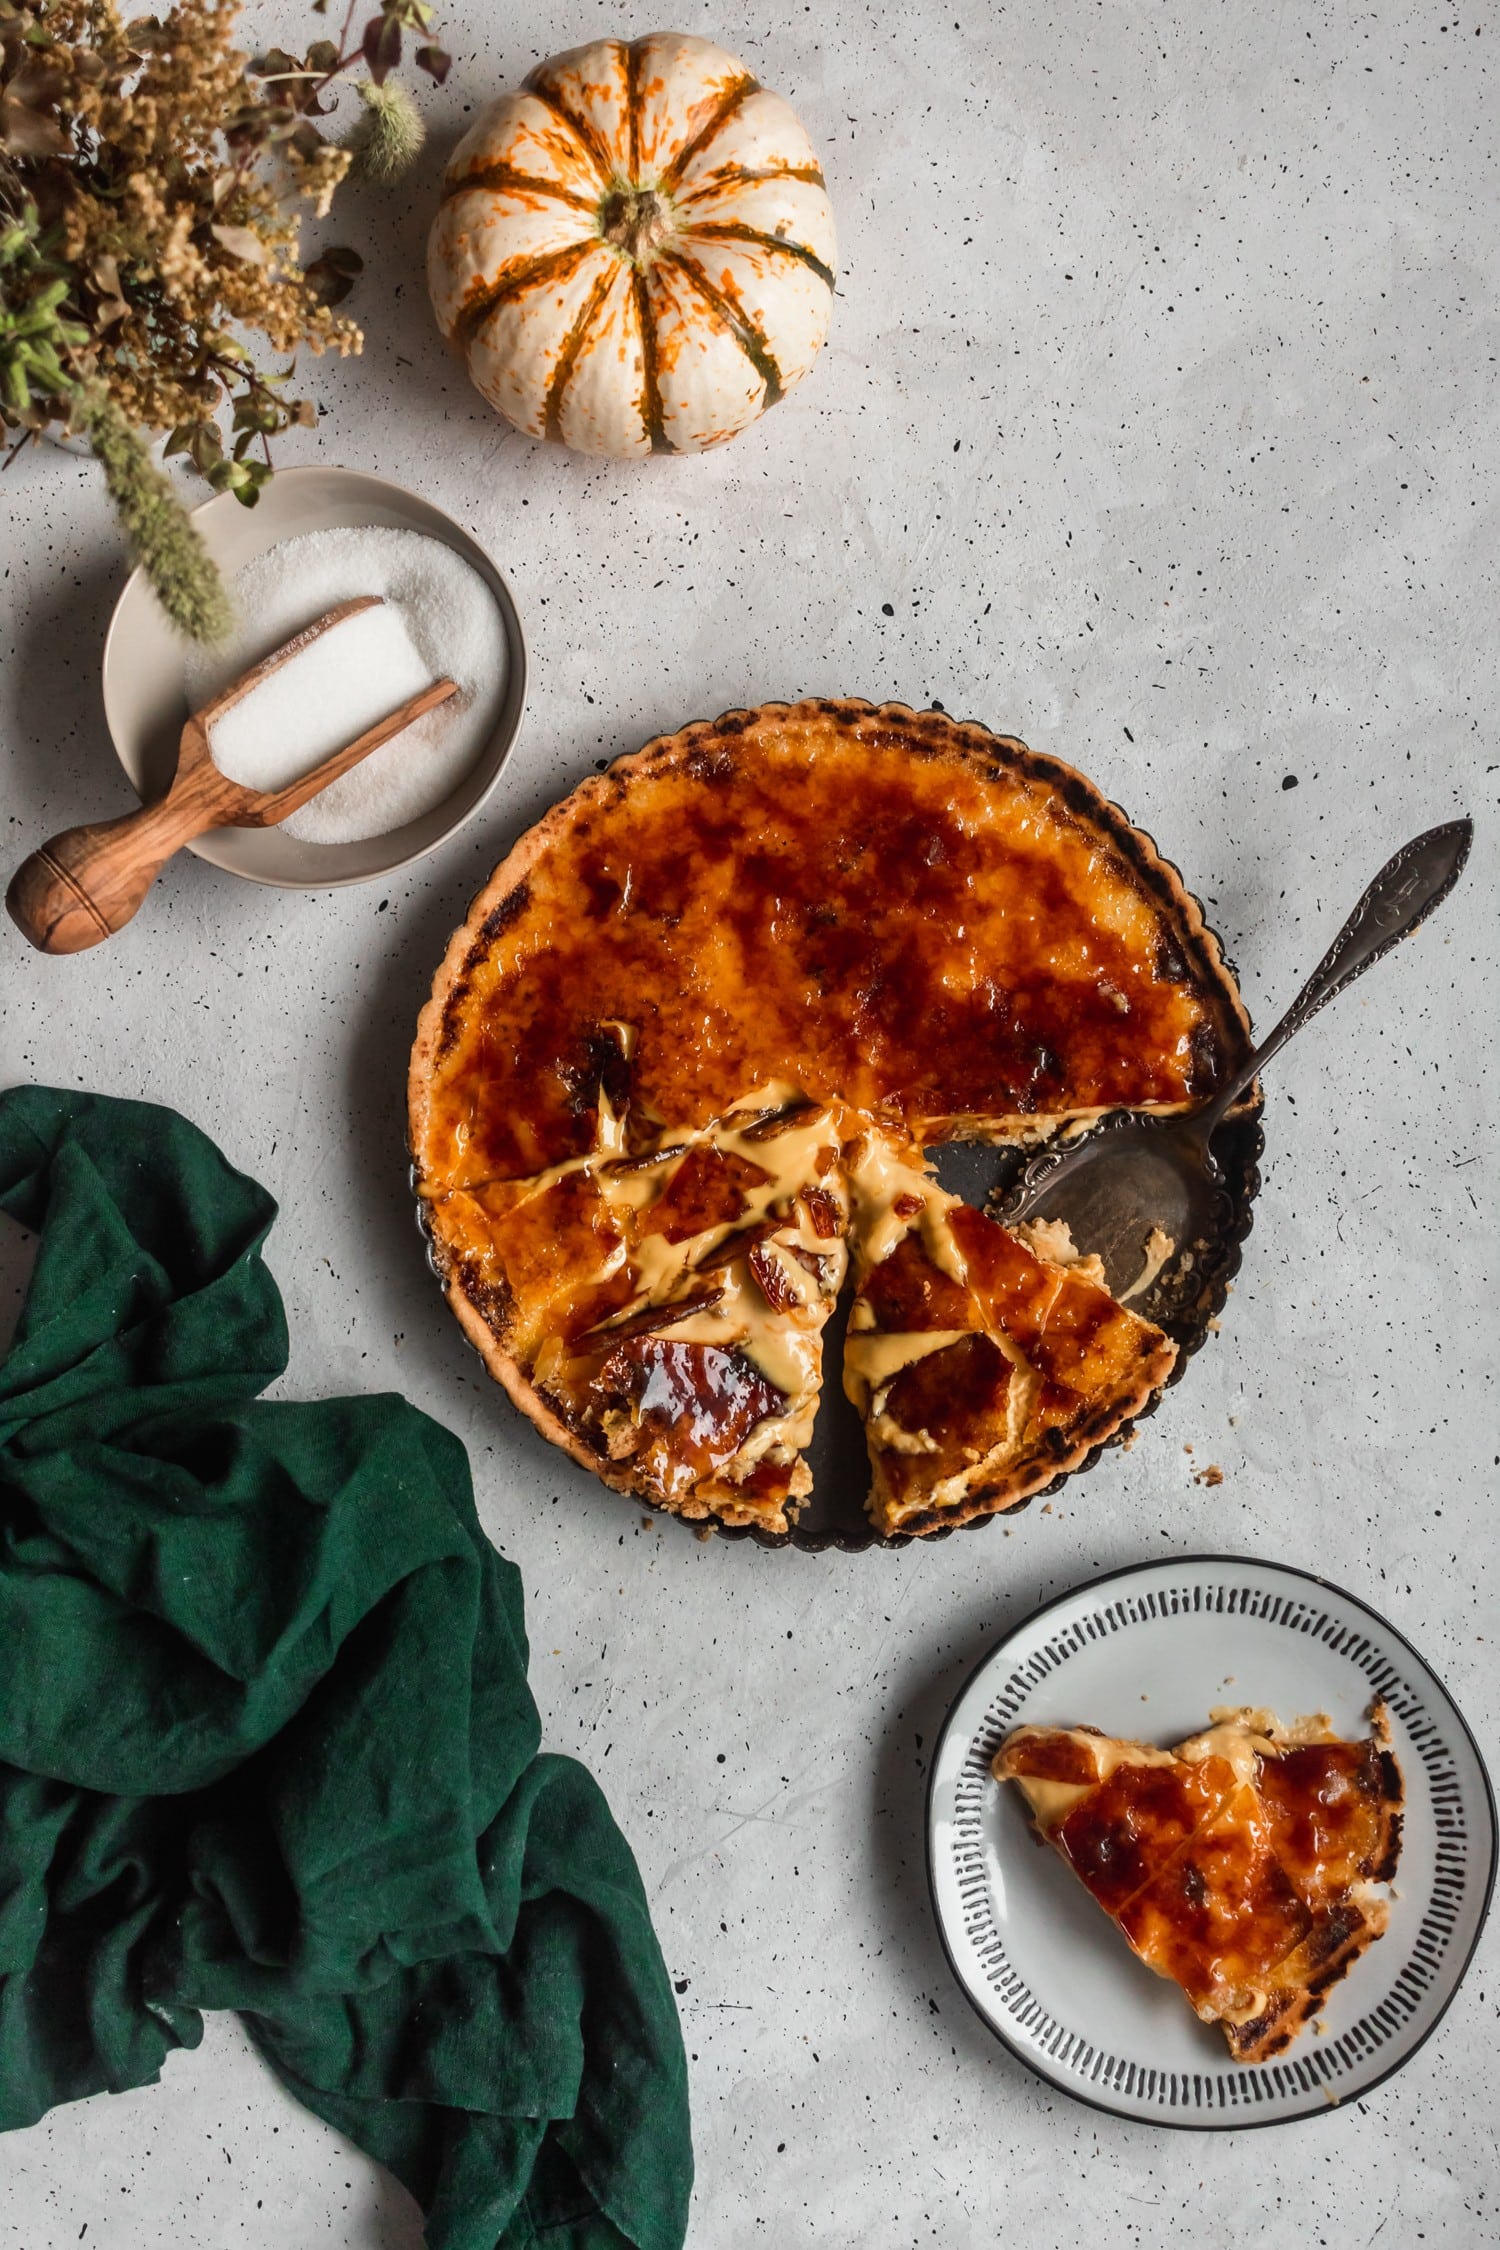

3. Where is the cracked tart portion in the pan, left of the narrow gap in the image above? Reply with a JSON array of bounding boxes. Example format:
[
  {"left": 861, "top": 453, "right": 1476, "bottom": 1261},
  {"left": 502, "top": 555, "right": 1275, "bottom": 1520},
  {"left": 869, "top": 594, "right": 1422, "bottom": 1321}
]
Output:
[{"left": 422, "top": 1087, "right": 848, "bottom": 1530}]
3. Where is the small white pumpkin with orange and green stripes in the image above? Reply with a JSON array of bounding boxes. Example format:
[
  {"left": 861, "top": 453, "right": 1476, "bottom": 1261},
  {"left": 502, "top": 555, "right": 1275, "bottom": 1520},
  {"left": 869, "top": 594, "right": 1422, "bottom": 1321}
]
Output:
[{"left": 427, "top": 32, "right": 837, "bottom": 457}]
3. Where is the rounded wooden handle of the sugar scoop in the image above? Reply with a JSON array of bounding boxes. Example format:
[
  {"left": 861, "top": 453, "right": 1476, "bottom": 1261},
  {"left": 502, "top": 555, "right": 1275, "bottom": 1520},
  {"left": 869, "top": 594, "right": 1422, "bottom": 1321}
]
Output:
[{"left": 4, "top": 799, "right": 216, "bottom": 954}]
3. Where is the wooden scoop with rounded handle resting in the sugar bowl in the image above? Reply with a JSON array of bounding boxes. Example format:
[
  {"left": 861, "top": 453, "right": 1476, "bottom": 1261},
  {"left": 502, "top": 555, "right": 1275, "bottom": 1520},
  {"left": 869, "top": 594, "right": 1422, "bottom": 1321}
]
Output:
[{"left": 4, "top": 594, "right": 457, "bottom": 954}]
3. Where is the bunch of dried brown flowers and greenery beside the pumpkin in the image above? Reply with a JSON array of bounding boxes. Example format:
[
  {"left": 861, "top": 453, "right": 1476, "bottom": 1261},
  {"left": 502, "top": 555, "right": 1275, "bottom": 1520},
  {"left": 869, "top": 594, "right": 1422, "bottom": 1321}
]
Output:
[{"left": 0, "top": 0, "right": 448, "bottom": 637}]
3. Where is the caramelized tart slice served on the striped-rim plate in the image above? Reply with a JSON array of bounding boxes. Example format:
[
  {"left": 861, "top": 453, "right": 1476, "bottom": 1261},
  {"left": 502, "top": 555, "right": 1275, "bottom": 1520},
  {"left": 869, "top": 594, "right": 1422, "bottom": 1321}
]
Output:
[{"left": 994, "top": 1703, "right": 1403, "bottom": 2063}]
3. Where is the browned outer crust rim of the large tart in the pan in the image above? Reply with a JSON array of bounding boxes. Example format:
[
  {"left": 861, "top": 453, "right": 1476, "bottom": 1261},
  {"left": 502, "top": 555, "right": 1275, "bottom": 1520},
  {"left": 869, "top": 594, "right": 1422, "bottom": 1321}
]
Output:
[{"left": 407, "top": 695, "right": 1250, "bottom": 1537}]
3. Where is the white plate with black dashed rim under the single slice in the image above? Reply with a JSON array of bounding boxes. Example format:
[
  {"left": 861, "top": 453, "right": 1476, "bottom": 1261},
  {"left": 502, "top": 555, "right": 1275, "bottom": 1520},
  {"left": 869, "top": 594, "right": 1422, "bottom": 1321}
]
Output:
[{"left": 927, "top": 1555, "right": 1496, "bottom": 2131}]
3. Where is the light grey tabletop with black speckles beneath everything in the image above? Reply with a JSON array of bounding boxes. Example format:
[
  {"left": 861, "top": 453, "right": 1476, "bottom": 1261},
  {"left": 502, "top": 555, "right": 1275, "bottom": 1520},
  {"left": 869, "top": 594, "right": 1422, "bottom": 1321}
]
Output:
[{"left": 0, "top": 0, "right": 1500, "bottom": 2250}]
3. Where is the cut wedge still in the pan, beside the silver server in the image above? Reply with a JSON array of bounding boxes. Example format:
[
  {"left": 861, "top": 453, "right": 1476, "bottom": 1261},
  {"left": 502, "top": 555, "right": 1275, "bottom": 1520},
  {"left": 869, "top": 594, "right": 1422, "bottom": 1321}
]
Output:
[{"left": 843, "top": 1134, "right": 1176, "bottom": 1532}]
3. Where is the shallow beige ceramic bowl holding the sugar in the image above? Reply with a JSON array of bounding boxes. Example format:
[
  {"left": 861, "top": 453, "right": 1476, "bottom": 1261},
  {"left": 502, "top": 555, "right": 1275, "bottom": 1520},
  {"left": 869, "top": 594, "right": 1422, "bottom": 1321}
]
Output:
[{"left": 103, "top": 468, "right": 526, "bottom": 891}]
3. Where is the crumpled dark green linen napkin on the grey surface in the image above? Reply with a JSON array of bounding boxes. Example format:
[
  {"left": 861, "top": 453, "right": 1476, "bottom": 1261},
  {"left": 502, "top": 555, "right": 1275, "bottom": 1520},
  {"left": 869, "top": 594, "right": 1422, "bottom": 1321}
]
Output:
[{"left": 0, "top": 1087, "right": 693, "bottom": 2250}]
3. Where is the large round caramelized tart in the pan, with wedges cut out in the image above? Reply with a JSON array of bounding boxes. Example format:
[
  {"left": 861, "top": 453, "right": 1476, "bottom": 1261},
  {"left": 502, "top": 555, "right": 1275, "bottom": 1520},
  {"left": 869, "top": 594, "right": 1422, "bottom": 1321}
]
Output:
[{"left": 409, "top": 702, "right": 1248, "bottom": 1532}]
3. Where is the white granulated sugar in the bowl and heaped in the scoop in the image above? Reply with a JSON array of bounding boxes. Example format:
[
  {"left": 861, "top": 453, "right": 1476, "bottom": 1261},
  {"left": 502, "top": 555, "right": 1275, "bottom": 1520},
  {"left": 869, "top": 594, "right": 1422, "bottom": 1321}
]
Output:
[{"left": 184, "top": 524, "right": 506, "bottom": 844}]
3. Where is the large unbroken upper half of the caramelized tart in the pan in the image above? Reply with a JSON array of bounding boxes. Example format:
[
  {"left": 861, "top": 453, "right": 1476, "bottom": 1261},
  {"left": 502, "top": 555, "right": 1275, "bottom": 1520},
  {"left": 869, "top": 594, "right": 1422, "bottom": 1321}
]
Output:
[{"left": 416, "top": 704, "right": 1244, "bottom": 1193}]
